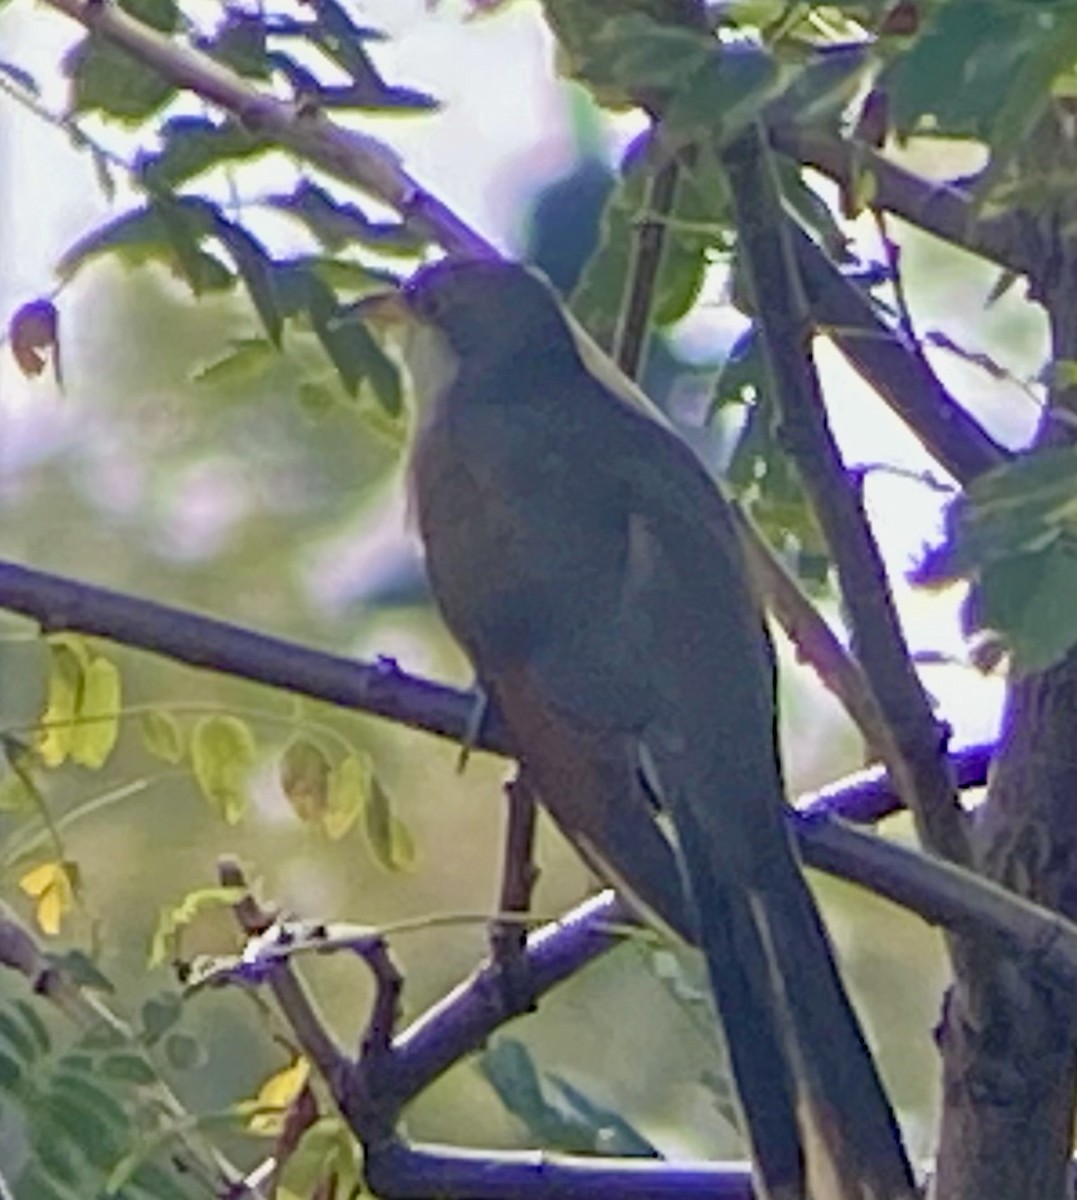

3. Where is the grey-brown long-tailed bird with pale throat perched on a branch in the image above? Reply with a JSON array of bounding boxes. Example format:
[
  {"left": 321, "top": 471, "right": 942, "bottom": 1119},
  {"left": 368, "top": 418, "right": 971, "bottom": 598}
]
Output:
[{"left": 366, "top": 258, "right": 914, "bottom": 1200}]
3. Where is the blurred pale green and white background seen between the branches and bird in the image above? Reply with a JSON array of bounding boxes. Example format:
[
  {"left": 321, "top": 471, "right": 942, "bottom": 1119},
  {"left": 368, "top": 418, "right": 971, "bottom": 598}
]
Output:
[{"left": 0, "top": 0, "right": 1042, "bottom": 1185}]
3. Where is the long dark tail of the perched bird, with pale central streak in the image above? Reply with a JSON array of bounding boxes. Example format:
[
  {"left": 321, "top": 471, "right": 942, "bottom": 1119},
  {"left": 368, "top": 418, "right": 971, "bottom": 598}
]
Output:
[{"left": 679, "top": 815, "right": 914, "bottom": 1200}]
